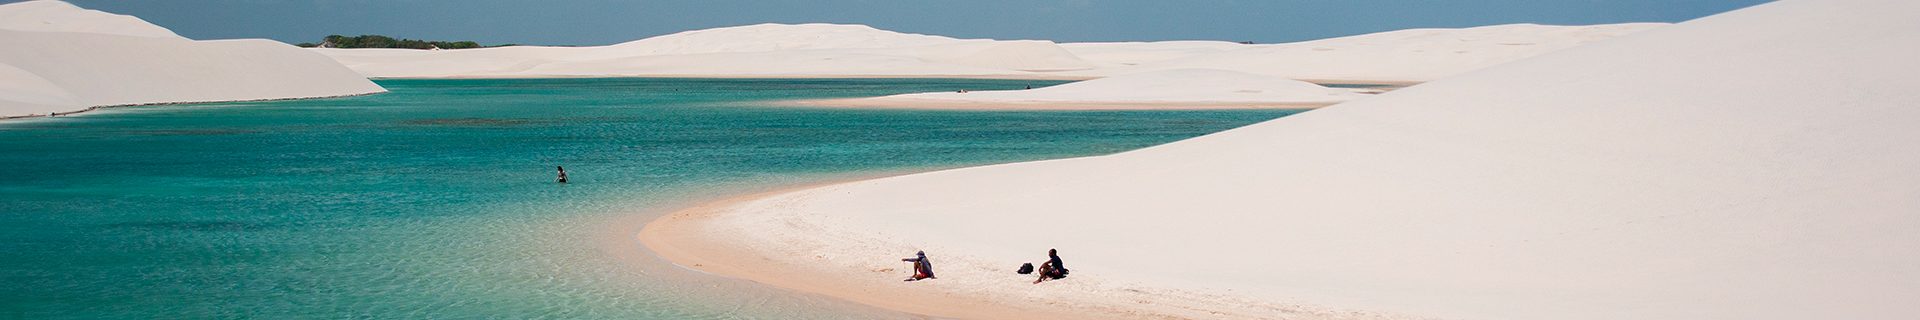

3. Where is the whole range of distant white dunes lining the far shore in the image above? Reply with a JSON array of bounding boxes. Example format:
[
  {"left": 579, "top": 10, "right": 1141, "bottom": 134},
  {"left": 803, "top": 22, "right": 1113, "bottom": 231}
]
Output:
[{"left": 317, "top": 23, "right": 1665, "bottom": 82}]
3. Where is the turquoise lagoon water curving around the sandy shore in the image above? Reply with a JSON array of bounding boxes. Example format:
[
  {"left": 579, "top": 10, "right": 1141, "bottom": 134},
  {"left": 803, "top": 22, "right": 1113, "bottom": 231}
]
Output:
[{"left": 0, "top": 79, "right": 1296, "bottom": 318}]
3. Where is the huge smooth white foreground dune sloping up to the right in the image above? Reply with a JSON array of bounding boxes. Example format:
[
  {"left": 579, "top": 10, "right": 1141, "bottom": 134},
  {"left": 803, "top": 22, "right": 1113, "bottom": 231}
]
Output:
[{"left": 649, "top": 0, "right": 1920, "bottom": 320}]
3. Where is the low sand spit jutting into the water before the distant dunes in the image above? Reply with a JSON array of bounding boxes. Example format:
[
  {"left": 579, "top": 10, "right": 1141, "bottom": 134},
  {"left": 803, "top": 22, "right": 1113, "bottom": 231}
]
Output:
[{"left": 812, "top": 69, "right": 1361, "bottom": 109}]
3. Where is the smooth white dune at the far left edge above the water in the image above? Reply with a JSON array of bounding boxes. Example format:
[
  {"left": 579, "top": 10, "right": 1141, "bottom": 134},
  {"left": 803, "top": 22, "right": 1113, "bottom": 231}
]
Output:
[{"left": 0, "top": 0, "right": 386, "bottom": 117}]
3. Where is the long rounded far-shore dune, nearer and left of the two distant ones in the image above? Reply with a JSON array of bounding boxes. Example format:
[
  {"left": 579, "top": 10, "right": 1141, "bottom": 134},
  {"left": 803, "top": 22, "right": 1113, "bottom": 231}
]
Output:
[{"left": 317, "top": 23, "right": 1094, "bottom": 79}]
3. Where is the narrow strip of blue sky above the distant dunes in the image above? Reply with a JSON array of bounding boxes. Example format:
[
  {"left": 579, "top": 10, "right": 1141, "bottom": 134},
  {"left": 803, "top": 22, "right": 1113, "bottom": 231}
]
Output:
[{"left": 33, "top": 0, "right": 1764, "bottom": 46}]
